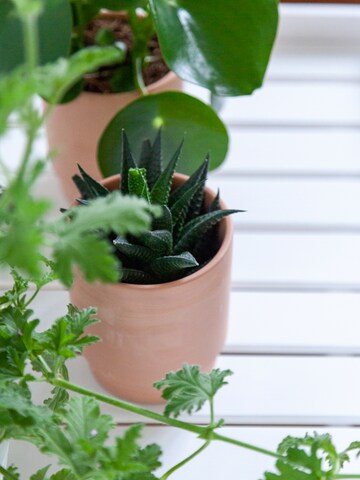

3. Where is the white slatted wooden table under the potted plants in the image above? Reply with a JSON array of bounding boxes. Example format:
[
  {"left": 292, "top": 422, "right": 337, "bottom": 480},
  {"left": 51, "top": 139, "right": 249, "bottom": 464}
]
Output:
[{"left": 0, "top": 6, "right": 360, "bottom": 480}]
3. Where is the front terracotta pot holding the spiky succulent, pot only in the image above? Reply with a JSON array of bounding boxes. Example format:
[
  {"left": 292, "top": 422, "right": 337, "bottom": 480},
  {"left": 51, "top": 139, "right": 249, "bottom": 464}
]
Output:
[{"left": 70, "top": 174, "right": 233, "bottom": 403}]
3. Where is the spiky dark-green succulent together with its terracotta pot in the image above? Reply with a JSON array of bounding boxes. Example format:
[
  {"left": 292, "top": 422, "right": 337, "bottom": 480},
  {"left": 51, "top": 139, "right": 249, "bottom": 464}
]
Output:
[{"left": 70, "top": 132, "right": 237, "bottom": 403}]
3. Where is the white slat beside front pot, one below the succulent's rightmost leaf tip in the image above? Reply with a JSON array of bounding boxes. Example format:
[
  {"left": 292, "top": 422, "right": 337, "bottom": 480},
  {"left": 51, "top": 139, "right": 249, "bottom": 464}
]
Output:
[{"left": 232, "top": 233, "right": 360, "bottom": 288}]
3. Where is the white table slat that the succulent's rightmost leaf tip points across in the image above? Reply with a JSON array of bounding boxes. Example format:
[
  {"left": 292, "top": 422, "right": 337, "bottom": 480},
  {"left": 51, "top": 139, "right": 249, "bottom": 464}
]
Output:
[{"left": 208, "top": 176, "right": 360, "bottom": 230}]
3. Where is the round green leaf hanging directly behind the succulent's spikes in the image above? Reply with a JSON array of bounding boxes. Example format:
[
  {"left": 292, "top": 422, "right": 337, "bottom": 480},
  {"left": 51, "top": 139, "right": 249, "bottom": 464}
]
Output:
[{"left": 98, "top": 92, "right": 228, "bottom": 177}]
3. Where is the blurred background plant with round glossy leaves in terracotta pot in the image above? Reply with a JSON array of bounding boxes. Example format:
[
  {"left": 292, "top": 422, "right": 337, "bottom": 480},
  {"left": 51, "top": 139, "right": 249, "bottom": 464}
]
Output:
[{"left": 0, "top": 0, "right": 277, "bottom": 199}]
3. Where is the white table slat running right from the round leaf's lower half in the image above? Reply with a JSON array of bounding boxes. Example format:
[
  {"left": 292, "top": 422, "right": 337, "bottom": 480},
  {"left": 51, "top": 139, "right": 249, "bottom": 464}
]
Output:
[{"left": 218, "top": 126, "right": 360, "bottom": 174}]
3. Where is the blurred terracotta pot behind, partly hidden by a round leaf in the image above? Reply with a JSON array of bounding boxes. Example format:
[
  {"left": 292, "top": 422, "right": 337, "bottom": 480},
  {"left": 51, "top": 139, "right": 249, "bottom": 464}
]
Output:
[{"left": 46, "top": 72, "right": 182, "bottom": 200}]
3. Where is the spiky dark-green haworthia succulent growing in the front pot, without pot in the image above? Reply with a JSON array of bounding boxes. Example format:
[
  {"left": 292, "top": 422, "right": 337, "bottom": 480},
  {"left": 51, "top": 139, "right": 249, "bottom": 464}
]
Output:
[{"left": 73, "top": 131, "right": 241, "bottom": 284}]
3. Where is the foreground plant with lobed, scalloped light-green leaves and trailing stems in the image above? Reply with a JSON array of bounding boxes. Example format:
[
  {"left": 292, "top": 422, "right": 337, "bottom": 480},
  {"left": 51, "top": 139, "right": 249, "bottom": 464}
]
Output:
[{"left": 0, "top": 4, "right": 360, "bottom": 480}]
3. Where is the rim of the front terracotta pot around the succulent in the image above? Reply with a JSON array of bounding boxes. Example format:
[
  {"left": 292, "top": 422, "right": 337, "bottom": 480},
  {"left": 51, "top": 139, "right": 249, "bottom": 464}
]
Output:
[{"left": 94, "top": 173, "right": 233, "bottom": 291}]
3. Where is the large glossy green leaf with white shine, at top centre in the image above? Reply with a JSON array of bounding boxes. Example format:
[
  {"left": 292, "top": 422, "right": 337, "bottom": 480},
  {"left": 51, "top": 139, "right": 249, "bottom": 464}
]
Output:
[{"left": 149, "top": 0, "right": 278, "bottom": 96}]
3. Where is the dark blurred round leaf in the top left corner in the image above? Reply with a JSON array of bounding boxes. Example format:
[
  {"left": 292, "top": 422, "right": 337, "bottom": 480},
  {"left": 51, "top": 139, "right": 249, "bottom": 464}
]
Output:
[{"left": 0, "top": 0, "right": 72, "bottom": 74}]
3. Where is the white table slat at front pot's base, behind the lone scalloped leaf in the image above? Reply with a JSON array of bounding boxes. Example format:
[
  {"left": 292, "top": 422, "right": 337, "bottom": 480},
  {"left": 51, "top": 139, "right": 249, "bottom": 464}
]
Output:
[{"left": 24, "top": 347, "right": 360, "bottom": 426}]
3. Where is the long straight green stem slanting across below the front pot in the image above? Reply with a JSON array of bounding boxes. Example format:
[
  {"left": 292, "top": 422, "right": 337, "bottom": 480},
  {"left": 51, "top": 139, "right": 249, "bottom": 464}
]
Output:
[{"left": 44, "top": 378, "right": 280, "bottom": 458}]
